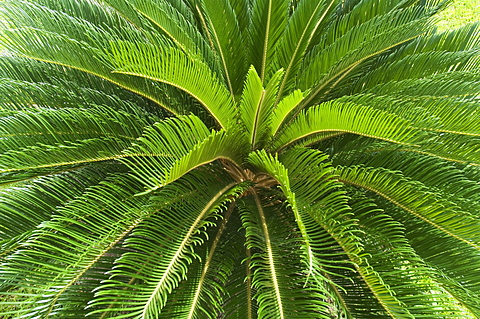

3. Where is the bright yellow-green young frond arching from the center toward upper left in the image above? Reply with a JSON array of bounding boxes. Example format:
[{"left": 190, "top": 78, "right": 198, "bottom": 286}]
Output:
[{"left": 110, "top": 42, "right": 235, "bottom": 128}]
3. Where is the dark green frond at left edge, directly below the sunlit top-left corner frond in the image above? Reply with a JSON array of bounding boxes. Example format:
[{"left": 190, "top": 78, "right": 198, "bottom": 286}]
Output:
[{"left": 0, "top": 55, "right": 164, "bottom": 117}]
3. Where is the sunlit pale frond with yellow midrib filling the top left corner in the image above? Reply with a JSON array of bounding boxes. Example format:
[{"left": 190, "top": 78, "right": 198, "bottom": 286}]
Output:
[{"left": 0, "top": 1, "right": 184, "bottom": 114}]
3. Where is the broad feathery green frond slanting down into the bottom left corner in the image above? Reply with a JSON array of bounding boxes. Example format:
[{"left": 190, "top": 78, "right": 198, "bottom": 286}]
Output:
[{"left": 1, "top": 175, "right": 145, "bottom": 318}]
